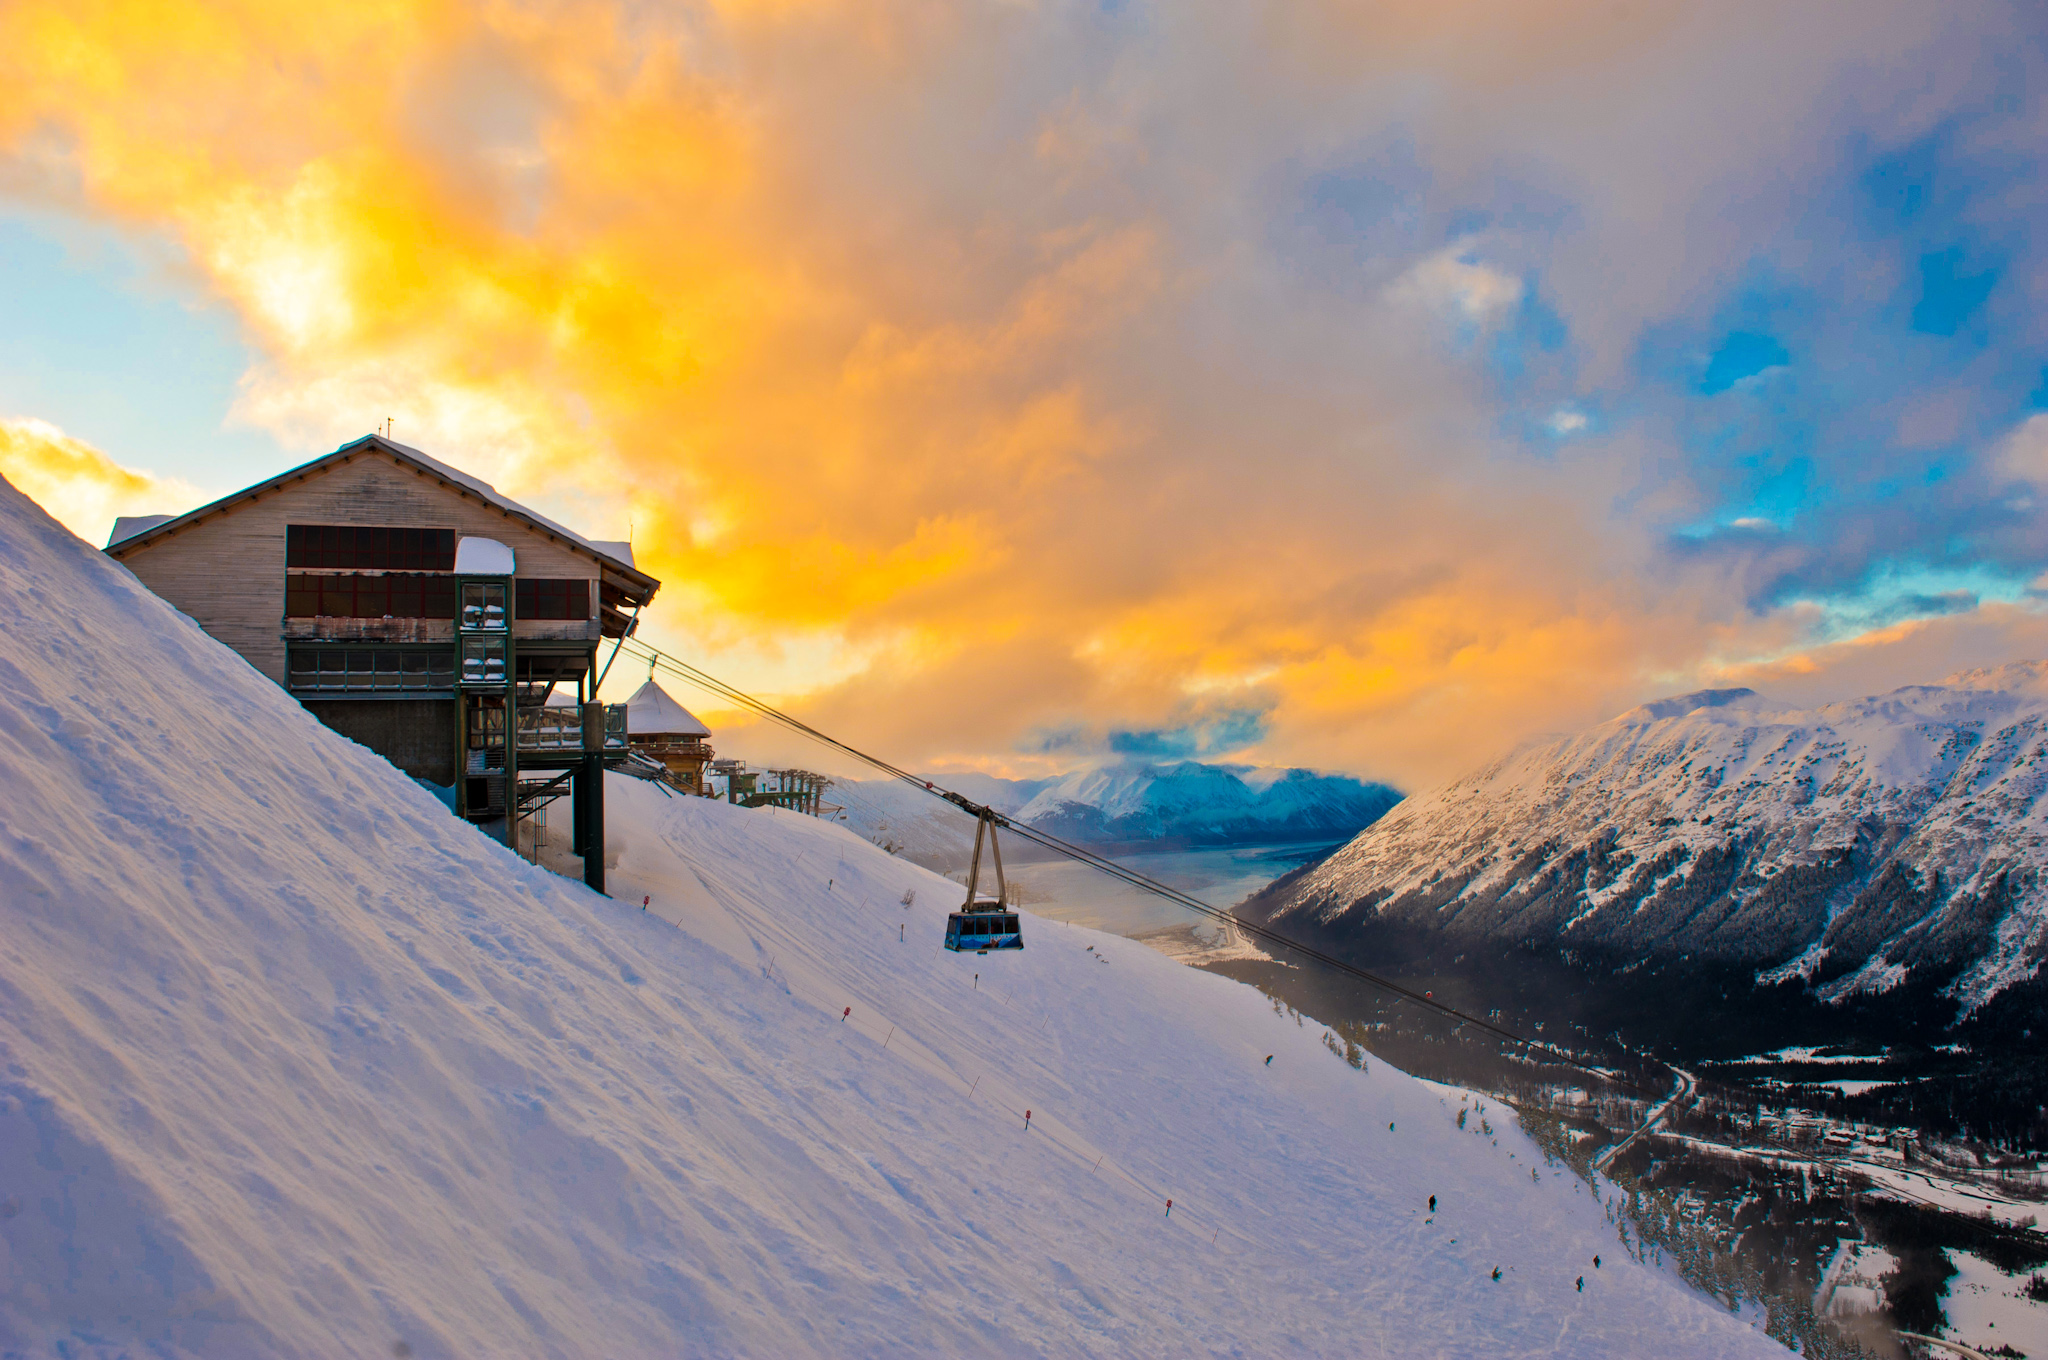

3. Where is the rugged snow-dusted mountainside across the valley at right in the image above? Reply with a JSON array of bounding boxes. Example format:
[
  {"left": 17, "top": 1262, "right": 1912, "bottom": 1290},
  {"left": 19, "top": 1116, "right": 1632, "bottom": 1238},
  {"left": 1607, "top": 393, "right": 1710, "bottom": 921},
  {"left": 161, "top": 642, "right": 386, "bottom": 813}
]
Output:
[{"left": 1255, "top": 664, "right": 2048, "bottom": 1012}]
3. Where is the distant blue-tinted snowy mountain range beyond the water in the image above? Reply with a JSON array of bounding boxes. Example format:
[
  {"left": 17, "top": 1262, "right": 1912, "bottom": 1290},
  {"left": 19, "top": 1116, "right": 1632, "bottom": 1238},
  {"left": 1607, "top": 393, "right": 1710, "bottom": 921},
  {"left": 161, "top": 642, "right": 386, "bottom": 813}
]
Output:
[{"left": 831, "top": 760, "right": 1401, "bottom": 868}]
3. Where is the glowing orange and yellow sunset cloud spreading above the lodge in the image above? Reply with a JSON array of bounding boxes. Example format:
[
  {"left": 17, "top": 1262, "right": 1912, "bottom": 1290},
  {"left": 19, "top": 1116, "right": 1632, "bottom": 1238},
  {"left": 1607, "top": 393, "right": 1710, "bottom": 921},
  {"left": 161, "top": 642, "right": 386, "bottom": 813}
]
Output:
[{"left": 0, "top": 0, "right": 1998, "bottom": 782}]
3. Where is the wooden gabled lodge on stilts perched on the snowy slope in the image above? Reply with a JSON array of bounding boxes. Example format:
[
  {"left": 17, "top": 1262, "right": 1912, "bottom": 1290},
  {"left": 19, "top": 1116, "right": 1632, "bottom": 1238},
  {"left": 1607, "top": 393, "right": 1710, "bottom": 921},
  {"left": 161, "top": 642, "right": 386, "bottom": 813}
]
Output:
[{"left": 106, "top": 434, "right": 663, "bottom": 889}]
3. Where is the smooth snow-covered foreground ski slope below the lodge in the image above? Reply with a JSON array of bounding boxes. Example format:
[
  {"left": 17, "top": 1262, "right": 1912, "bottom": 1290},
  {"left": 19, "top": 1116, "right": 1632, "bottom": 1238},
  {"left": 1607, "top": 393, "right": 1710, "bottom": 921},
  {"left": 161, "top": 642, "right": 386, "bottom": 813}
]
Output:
[{"left": 0, "top": 473, "right": 1782, "bottom": 1358}]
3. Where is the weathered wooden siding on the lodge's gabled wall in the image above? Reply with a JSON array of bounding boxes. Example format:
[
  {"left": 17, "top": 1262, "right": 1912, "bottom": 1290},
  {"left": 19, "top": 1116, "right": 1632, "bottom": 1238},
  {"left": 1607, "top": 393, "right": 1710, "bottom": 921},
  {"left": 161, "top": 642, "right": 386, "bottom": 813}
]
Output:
[{"left": 109, "top": 451, "right": 598, "bottom": 684}]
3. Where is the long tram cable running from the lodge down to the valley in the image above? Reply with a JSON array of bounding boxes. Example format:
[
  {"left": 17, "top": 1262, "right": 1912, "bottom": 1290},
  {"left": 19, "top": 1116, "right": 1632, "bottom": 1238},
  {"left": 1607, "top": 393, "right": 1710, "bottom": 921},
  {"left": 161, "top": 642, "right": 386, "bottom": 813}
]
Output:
[{"left": 614, "top": 639, "right": 1663, "bottom": 1098}]
